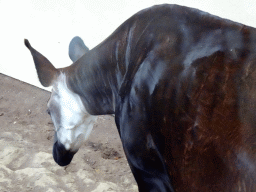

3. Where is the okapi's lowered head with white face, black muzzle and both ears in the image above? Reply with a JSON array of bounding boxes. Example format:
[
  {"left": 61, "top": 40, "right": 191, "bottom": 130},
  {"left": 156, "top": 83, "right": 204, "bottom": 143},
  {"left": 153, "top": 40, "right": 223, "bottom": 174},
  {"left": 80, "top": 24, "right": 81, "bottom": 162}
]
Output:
[{"left": 25, "top": 37, "right": 97, "bottom": 166}]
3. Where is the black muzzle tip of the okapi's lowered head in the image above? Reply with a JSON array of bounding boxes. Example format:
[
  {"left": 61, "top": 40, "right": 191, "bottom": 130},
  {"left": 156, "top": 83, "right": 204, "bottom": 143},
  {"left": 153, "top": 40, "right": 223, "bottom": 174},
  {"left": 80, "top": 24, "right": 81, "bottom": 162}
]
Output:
[{"left": 52, "top": 141, "right": 77, "bottom": 166}]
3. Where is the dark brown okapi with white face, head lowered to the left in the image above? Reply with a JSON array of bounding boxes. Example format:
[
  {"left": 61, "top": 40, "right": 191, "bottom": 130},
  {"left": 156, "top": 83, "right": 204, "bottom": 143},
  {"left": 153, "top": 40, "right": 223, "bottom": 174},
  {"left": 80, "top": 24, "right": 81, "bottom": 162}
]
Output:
[{"left": 25, "top": 5, "right": 256, "bottom": 192}]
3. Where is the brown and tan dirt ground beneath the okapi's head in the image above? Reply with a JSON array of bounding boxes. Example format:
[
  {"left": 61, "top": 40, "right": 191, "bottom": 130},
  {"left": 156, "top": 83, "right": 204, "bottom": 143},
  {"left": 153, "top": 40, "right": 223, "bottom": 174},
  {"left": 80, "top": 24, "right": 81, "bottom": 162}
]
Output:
[{"left": 0, "top": 74, "right": 138, "bottom": 192}]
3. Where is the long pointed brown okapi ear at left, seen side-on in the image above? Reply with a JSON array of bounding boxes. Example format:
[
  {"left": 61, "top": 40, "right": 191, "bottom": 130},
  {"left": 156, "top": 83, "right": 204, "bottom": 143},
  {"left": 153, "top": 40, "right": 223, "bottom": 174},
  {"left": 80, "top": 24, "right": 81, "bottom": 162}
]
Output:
[{"left": 24, "top": 39, "right": 58, "bottom": 87}]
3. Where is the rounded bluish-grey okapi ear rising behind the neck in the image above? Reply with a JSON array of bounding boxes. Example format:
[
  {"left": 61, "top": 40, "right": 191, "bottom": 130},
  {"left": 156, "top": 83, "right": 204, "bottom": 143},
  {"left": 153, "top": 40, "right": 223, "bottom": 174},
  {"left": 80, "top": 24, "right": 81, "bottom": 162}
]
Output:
[{"left": 68, "top": 36, "right": 89, "bottom": 62}]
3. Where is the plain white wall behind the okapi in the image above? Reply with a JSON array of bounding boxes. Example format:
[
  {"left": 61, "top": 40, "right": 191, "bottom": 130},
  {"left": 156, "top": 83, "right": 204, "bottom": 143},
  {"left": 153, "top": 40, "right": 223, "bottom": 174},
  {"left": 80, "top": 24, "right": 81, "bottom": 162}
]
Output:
[{"left": 0, "top": 0, "right": 256, "bottom": 90}]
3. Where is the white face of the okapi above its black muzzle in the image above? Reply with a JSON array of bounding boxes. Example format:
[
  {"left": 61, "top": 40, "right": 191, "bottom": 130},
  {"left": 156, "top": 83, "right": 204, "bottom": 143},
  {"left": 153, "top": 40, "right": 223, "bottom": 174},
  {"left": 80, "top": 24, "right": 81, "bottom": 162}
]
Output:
[{"left": 48, "top": 73, "right": 97, "bottom": 151}]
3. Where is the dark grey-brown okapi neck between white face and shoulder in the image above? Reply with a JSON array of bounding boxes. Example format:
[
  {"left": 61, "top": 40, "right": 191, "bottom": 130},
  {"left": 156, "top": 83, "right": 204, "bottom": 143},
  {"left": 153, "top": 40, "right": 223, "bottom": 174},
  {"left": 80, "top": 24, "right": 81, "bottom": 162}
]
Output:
[{"left": 63, "top": 44, "right": 122, "bottom": 115}]
